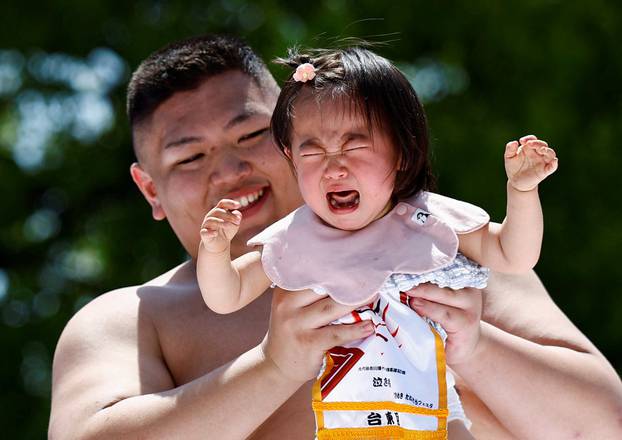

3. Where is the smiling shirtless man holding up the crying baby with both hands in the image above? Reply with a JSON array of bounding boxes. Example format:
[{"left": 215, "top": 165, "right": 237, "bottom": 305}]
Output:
[{"left": 49, "top": 37, "right": 622, "bottom": 440}]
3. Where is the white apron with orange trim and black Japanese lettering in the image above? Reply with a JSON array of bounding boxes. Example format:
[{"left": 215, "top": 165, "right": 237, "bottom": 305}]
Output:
[{"left": 313, "top": 293, "right": 448, "bottom": 440}]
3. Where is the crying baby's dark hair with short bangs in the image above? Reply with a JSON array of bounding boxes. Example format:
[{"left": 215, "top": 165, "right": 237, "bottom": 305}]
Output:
[{"left": 271, "top": 46, "right": 434, "bottom": 201}]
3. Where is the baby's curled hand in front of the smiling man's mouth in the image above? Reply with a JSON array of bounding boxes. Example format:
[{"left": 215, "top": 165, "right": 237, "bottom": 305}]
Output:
[{"left": 201, "top": 199, "right": 242, "bottom": 253}]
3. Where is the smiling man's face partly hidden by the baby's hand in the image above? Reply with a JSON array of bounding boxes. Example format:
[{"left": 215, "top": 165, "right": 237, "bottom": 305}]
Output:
[{"left": 132, "top": 71, "right": 302, "bottom": 257}]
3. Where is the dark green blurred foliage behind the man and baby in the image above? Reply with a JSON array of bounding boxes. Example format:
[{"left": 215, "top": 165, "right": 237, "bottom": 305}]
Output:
[{"left": 0, "top": 0, "right": 622, "bottom": 439}]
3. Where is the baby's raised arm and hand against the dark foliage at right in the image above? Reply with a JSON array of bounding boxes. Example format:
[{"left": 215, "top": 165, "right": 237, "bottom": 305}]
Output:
[{"left": 459, "top": 136, "right": 557, "bottom": 273}]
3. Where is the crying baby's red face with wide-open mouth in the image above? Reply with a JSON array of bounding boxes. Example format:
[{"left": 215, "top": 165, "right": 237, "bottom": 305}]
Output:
[{"left": 290, "top": 94, "right": 397, "bottom": 230}]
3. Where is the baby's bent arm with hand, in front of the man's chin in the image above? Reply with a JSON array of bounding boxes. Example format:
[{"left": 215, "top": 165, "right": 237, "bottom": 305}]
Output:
[{"left": 197, "top": 199, "right": 270, "bottom": 313}]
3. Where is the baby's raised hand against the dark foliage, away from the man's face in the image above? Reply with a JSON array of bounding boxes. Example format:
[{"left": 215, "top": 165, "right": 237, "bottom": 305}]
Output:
[{"left": 504, "top": 135, "right": 557, "bottom": 191}]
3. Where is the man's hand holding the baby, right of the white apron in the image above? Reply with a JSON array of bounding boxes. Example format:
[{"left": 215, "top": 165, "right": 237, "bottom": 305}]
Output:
[{"left": 406, "top": 283, "right": 482, "bottom": 366}]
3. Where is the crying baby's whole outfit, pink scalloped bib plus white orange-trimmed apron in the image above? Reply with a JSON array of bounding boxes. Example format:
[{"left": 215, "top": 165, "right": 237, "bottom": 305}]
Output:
[{"left": 249, "top": 192, "right": 489, "bottom": 440}]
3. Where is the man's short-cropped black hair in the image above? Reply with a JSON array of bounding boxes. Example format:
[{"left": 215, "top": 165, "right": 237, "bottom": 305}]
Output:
[{"left": 127, "top": 34, "right": 276, "bottom": 133}]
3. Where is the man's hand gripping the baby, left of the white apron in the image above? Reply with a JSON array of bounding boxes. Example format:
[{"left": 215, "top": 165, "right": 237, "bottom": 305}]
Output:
[{"left": 262, "top": 289, "right": 374, "bottom": 382}]
